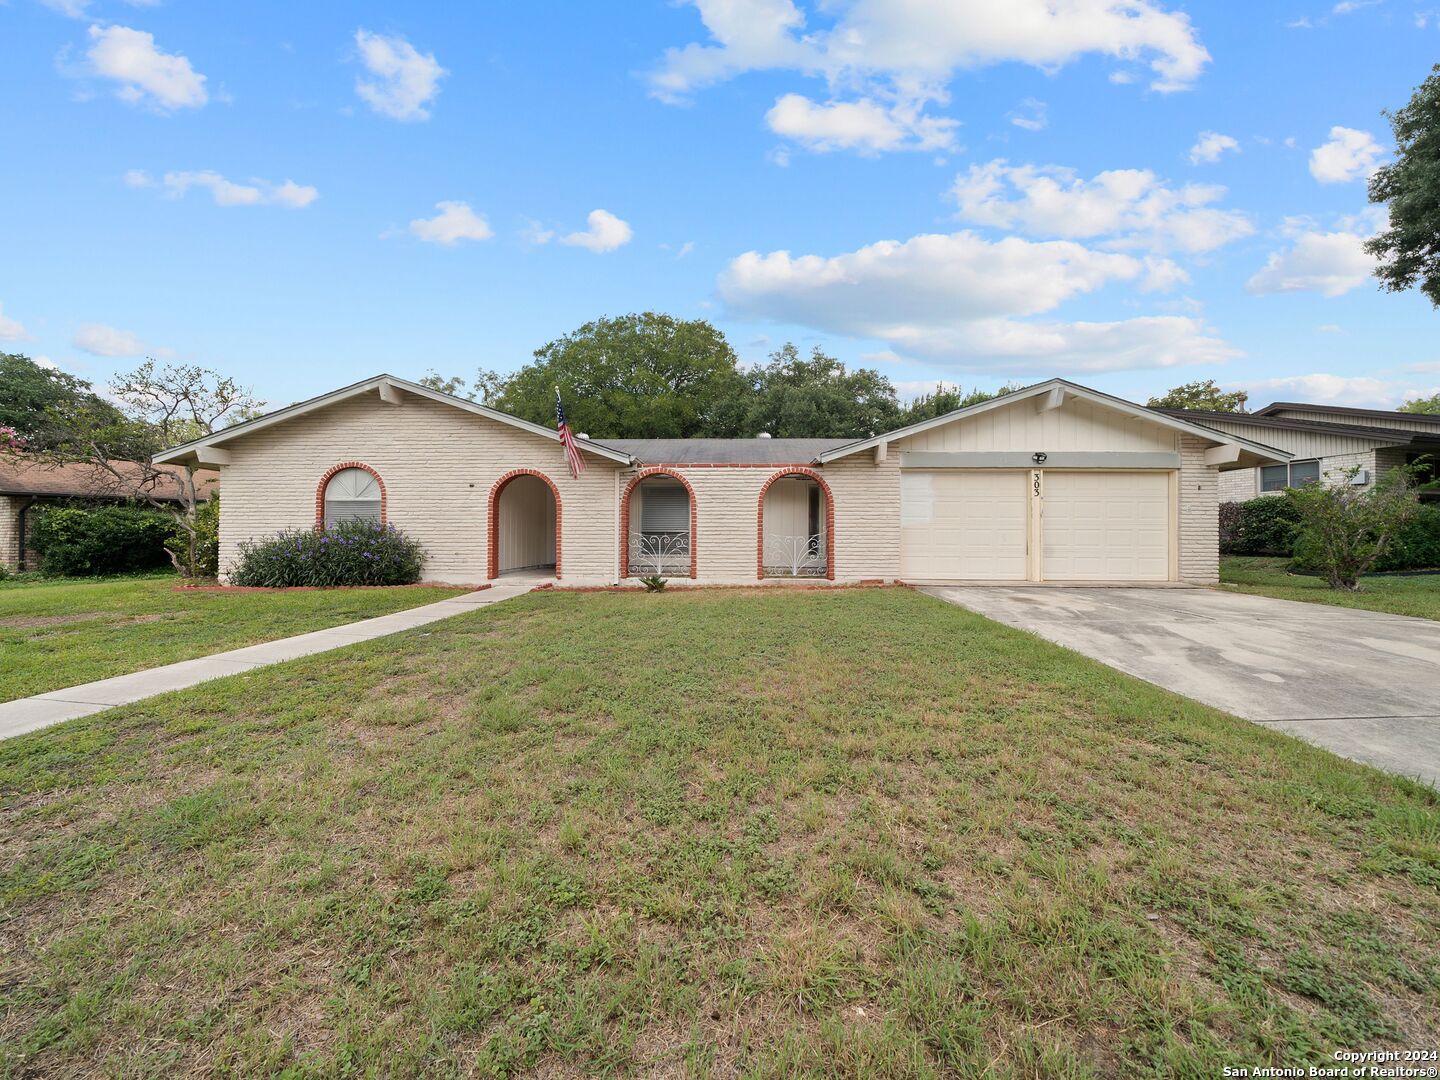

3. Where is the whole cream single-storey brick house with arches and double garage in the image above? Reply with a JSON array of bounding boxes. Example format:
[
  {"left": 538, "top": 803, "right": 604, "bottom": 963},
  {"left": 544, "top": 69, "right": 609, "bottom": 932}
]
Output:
[{"left": 151, "top": 374, "right": 1289, "bottom": 585}]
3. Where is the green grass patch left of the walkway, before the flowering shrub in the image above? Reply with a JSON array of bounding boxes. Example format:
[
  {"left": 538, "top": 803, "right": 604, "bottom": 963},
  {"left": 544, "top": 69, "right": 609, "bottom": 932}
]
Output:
[{"left": 0, "top": 575, "right": 461, "bottom": 701}]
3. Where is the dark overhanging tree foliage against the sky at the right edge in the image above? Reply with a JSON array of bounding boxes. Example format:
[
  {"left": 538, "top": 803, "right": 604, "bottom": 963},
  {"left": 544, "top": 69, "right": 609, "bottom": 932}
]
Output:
[{"left": 1365, "top": 63, "right": 1440, "bottom": 307}]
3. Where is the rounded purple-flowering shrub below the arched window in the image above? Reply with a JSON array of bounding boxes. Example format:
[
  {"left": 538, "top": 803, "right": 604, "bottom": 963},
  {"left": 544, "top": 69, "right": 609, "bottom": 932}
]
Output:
[{"left": 230, "top": 521, "right": 425, "bottom": 589}]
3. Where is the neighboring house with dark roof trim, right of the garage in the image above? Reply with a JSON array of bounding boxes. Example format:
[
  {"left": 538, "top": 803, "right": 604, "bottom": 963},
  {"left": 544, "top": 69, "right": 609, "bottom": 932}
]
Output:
[{"left": 1158, "top": 402, "right": 1440, "bottom": 503}]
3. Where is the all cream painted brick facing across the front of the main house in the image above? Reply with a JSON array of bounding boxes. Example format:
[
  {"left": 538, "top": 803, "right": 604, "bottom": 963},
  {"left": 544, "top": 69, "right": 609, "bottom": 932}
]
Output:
[{"left": 210, "top": 393, "right": 1238, "bottom": 585}]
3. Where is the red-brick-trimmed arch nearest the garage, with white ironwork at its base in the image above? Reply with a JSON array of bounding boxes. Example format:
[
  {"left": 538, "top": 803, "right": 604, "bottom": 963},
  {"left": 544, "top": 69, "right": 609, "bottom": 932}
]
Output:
[{"left": 755, "top": 468, "right": 835, "bottom": 580}]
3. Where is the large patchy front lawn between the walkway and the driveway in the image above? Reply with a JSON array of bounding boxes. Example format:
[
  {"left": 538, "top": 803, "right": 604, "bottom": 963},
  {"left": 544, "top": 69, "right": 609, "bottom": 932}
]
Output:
[{"left": 0, "top": 589, "right": 1440, "bottom": 1079}]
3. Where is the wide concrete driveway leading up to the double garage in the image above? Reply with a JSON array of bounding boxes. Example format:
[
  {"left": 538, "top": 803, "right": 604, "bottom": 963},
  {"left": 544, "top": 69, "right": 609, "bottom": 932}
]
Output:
[{"left": 923, "top": 586, "right": 1440, "bottom": 783}]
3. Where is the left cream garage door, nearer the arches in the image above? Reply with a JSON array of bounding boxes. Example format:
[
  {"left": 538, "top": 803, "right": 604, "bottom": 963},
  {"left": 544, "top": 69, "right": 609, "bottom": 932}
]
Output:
[{"left": 900, "top": 471, "right": 1030, "bottom": 582}]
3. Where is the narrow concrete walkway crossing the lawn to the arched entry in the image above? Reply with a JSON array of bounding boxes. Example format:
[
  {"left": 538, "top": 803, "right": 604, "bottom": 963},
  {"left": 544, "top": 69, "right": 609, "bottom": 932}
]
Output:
[{"left": 0, "top": 580, "right": 534, "bottom": 739}]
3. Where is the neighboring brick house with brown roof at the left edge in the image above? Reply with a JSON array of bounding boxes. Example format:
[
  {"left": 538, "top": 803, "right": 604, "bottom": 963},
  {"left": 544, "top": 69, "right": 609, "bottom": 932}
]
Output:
[{"left": 0, "top": 454, "right": 220, "bottom": 570}]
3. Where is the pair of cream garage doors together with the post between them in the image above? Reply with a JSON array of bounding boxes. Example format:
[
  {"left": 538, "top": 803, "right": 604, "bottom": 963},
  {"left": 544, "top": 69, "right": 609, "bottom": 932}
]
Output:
[{"left": 900, "top": 469, "right": 1174, "bottom": 582}]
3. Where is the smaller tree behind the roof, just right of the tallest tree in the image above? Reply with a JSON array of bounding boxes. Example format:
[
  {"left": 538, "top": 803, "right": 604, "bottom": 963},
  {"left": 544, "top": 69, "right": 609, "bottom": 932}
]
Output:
[{"left": 743, "top": 343, "right": 900, "bottom": 439}]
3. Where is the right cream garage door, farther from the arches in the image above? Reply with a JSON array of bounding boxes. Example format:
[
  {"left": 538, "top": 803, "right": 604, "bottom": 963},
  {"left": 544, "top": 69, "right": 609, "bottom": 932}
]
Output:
[{"left": 1041, "top": 471, "right": 1171, "bottom": 582}]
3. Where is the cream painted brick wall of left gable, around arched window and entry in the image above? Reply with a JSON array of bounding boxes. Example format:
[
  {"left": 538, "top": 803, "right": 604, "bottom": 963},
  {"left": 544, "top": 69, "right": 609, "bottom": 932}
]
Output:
[{"left": 220, "top": 395, "right": 621, "bottom": 583}]
